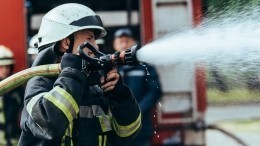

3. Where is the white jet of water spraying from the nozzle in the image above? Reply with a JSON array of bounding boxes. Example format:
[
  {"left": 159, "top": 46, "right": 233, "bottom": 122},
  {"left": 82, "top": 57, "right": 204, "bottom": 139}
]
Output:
[{"left": 137, "top": 10, "right": 260, "bottom": 70}]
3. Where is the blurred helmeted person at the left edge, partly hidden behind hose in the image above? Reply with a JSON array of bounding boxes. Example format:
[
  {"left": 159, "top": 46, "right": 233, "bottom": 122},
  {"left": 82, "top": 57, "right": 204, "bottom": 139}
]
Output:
[{"left": 0, "top": 45, "right": 24, "bottom": 146}]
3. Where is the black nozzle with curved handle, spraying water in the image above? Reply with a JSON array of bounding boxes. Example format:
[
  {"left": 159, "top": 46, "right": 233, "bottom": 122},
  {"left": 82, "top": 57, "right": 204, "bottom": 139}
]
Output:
[{"left": 78, "top": 42, "right": 140, "bottom": 70}]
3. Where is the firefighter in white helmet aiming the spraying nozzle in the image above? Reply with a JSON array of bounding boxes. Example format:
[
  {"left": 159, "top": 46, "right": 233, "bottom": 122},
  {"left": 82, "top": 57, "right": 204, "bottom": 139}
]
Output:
[{"left": 18, "top": 3, "right": 141, "bottom": 146}]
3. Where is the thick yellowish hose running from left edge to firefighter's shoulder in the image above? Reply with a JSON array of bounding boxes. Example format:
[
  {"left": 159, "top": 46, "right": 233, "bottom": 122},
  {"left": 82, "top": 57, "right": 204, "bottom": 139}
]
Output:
[{"left": 0, "top": 64, "right": 61, "bottom": 96}]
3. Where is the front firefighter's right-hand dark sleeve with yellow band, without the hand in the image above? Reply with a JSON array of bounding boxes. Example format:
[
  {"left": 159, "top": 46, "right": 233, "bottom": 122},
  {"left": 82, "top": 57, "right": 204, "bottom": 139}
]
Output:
[{"left": 108, "top": 86, "right": 142, "bottom": 145}]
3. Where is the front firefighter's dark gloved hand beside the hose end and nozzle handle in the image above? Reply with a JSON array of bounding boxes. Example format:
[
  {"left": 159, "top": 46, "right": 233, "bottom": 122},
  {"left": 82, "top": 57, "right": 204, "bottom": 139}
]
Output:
[{"left": 61, "top": 53, "right": 89, "bottom": 77}]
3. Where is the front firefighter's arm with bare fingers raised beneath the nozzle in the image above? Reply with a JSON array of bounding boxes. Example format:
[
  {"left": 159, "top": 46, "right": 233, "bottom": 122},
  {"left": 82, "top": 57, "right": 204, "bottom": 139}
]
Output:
[{"left": 102, "top": 70, "right": 141, "bottom": 145}]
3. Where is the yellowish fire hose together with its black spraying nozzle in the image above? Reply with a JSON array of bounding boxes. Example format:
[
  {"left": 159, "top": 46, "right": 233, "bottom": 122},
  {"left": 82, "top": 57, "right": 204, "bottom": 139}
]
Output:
[{"left": 0, "top": 42, "right": 140, "bottom": 96}]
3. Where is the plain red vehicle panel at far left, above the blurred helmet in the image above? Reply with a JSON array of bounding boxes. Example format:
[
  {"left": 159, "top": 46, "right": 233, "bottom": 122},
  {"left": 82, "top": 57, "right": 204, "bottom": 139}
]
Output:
[{"left": 0, "top": 0, "right": 26, "bottom": 72}]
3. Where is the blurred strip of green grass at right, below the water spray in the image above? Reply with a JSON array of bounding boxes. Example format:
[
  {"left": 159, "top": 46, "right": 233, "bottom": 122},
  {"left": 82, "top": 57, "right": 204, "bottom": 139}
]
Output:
[{"left": 207, "top": 88, "right": 260, "bottom": 104}]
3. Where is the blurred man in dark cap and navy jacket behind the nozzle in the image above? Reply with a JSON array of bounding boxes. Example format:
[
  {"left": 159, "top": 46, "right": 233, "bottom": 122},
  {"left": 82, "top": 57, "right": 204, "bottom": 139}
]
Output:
[{"left": 113, "top": 28, "right": 162, "bottom": 146}]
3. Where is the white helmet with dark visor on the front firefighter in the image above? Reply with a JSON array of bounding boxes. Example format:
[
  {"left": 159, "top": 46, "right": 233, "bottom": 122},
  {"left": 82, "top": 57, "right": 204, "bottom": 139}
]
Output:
[{"left": 38, "top": 3, "right": 106, "bottom": 48}]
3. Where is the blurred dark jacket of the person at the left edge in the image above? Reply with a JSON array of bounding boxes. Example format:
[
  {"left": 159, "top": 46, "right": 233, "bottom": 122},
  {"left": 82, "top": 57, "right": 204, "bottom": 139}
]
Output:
[{"left": 0, "top": 80, "right": 24, "bottom": 146}]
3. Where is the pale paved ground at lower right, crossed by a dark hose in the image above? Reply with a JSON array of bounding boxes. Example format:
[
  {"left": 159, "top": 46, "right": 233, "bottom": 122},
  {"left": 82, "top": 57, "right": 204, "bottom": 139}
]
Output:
[{"left": 206, "top": 105, "right": 260, "bottom": 146}]
